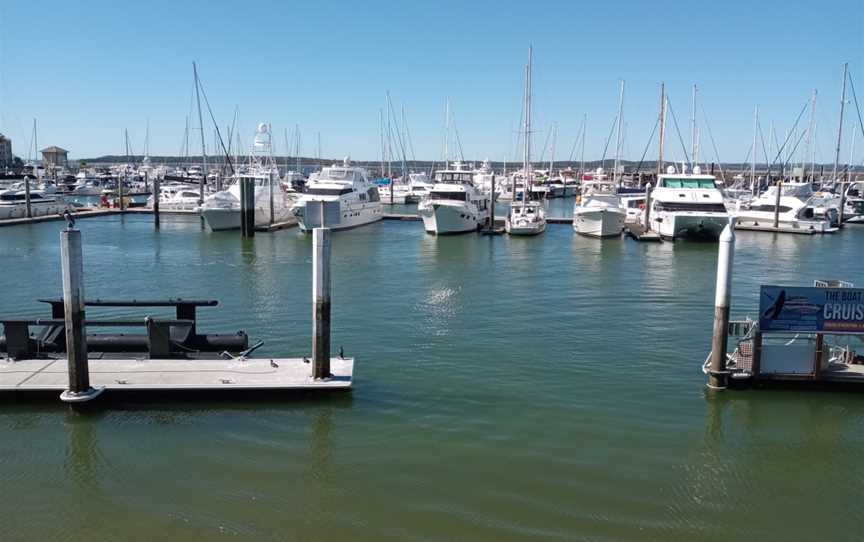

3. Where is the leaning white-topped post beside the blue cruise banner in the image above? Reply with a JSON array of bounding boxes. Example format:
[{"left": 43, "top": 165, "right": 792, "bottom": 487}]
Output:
[{"left": 708, "top": 218, "right": 735, "bottom": 390}]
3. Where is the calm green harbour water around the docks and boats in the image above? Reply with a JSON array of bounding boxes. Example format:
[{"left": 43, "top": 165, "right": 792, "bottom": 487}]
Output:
[{"left": 0, "top": 216, "right": 864, "bottom": 542}]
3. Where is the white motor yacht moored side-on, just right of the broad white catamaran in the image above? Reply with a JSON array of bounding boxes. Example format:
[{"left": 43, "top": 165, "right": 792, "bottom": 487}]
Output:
[{"left": 733, "top": 182, "right": 837, "bottom": 233}]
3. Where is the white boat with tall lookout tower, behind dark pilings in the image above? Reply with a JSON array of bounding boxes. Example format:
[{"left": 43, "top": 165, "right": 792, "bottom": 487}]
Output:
[{"left": 200, "top": 123, "right": 292, "bottom": 231}]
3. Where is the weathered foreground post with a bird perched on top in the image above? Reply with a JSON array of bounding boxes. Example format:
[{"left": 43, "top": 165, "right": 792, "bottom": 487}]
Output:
[{"left": 60, "top": 227, "right": 102, "bottom": 403}]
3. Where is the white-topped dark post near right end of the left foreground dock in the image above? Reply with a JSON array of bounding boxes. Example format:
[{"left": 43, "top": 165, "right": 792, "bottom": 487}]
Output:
[{"left": 312, "top": 227, "right": 331, "bottom": 380}]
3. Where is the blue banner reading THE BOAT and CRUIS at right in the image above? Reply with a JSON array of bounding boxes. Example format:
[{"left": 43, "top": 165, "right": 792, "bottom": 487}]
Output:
[{"left": 759, "top": 286, "right": 864, "bottom": 333}]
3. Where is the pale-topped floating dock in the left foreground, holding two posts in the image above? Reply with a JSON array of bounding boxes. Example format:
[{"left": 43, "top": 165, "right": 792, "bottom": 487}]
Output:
[{"left": 0, "top": 357, "right": 354, "bottom": 395}]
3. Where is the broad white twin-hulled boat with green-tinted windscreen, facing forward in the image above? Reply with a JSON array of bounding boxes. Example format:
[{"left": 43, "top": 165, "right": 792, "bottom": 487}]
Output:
[{"left": 650, "top": 164, "right": 729, "bottom": 241}]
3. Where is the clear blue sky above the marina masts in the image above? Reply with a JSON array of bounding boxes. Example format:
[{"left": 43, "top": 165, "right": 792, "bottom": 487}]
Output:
[{"left": 0, "top": 0, "right": 864, "bottom": 166}]
